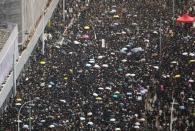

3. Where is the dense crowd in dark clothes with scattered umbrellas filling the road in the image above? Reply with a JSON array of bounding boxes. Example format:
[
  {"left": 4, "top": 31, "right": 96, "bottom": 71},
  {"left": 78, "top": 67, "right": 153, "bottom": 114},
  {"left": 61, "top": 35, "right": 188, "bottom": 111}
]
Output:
[{"left": 0, "top": 0, "right": 195, "bottom": 131}]
